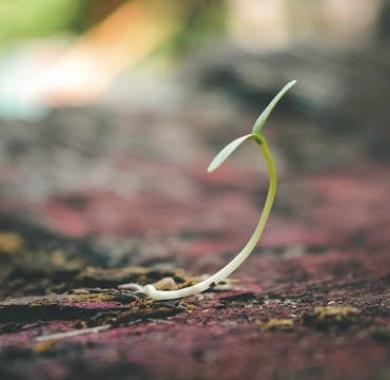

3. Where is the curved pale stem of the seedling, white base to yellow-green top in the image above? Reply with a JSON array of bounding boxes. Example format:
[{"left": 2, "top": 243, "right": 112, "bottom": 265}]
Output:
[{"left": 123, "top": 134, "right": 277, "bottom": 301}]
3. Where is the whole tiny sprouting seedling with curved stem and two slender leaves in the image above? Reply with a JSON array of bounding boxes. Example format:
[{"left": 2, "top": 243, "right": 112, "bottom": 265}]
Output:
[{"left": 120, "top": 80, "right": 296, "bottom": 301}]
